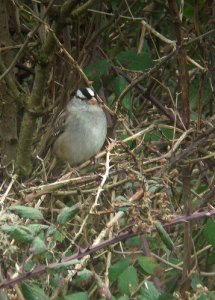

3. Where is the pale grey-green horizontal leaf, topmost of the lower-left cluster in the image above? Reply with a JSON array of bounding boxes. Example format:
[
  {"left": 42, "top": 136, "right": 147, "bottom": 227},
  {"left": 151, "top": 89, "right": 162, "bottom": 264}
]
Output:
[{"left": 8, "top": 205, "right": 43, "bottom": 220}]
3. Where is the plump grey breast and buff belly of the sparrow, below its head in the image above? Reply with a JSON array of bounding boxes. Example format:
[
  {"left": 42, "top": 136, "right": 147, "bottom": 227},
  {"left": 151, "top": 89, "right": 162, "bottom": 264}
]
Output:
[{"left": 55, "top": 105, "right": 107, "bottom": 166}]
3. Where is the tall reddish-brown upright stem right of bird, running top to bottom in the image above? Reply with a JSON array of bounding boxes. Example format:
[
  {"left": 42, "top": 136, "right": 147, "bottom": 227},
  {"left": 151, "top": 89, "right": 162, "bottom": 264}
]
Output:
[{"left": 168, "top": 0, "right": 192, "bottom": 299}]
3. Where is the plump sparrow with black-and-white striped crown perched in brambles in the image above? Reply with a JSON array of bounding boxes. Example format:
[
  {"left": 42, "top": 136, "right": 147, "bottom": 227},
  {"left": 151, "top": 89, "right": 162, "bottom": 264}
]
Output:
[{"left": 53, "top": 87, "right": 107, "bottom": 166}]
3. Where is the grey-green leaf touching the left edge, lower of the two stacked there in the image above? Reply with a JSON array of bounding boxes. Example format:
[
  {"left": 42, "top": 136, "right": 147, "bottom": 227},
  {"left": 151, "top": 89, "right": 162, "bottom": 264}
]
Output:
[{"left": 1, "top": 224, "right": 34, "bottom": 243}]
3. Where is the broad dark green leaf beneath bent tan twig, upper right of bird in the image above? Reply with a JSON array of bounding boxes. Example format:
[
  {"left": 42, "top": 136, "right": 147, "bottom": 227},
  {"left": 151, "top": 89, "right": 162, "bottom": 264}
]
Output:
[{"left": 116, "top": 50, "right": 152, "bottom": 71}]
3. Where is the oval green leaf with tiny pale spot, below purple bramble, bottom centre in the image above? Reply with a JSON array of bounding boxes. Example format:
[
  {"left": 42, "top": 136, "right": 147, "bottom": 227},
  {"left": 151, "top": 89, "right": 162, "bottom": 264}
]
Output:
[{"left": 118, "top": 266, "right": 138, "bottom": 295}]
